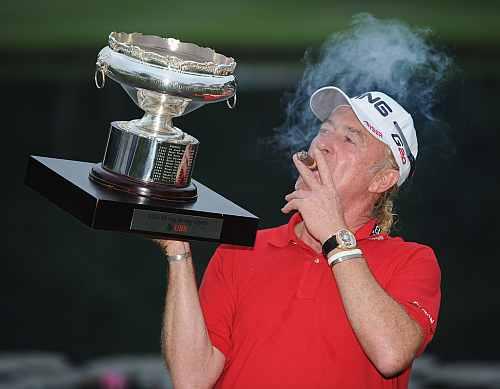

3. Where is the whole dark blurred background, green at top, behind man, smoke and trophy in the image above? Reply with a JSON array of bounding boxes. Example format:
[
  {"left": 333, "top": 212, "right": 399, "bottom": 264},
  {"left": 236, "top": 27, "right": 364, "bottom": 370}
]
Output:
[{"left": 0, "top": 0, "right": 500, "bottom": 388}]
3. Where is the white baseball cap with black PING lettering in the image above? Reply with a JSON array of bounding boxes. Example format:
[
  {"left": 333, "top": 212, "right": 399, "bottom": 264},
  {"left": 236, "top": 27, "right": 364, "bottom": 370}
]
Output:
[{"left": 309, "top": 86, "right": 418, "bottom": 186}]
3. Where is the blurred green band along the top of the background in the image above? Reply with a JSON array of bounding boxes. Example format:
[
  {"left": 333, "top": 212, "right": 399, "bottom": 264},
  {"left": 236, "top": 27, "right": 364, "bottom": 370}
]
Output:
[{"left": 0, "top": 0, "right": 500, "bottom": 49}]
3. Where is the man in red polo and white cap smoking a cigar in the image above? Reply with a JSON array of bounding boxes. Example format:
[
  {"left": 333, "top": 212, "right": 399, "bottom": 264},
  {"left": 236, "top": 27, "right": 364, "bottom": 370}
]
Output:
[{"left": 160, "top": 87, "right": 440, "bottom": 388}]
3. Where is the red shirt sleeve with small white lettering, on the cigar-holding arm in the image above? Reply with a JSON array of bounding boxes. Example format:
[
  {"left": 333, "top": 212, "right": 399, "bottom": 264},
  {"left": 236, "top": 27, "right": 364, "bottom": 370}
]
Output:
[{"left": 386, "top": 246, "right": 441, "bottom": 356}]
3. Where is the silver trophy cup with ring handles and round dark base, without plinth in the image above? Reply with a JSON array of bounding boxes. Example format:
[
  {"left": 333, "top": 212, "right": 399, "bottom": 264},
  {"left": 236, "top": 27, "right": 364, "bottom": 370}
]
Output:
[{"left": 90, "top": 32, "right": 236, "bottom": 202}]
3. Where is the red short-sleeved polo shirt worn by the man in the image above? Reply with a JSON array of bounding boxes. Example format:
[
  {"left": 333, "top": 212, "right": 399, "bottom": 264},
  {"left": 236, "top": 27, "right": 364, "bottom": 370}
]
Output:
[{"left": 200, "top": 213, "right": 440, "bottom": 389}]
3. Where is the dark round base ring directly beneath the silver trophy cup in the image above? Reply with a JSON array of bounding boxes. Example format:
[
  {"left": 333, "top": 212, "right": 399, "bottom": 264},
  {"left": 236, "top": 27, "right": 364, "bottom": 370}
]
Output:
[{"left": 89, "top": 163, "right": 198, "bottom": 203}]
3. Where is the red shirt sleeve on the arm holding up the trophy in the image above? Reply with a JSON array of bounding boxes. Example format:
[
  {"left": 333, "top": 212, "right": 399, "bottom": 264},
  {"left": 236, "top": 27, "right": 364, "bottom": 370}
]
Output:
[{"left": 199, "top": 247, "right": 235, "bottom": 360}]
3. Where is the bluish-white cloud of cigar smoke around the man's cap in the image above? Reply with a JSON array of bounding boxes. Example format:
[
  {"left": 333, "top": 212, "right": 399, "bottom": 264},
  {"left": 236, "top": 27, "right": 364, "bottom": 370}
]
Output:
[{"left": 271, "top": 14, "right": 451, "bottom": 159}]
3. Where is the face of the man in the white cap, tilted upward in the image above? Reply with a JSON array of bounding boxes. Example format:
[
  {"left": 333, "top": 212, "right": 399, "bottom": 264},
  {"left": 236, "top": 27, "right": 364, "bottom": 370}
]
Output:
[{"left": 295, "top": 106, "right": 392, "bottom": 204}]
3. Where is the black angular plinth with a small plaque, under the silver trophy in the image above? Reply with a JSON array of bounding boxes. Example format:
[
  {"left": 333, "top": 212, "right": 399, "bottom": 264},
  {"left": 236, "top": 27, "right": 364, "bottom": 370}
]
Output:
[{"left": 25, "top": 156, "right": 259, "bottom": 246}]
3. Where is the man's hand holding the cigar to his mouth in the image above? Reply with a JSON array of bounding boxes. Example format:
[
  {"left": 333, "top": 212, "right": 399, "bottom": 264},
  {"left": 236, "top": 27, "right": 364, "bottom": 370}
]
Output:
[{"left": 281, "top": 148, "right": 346, "bottom": 243}]
